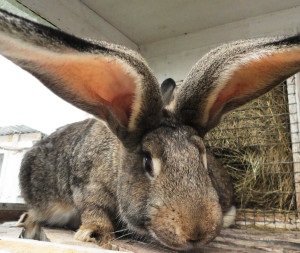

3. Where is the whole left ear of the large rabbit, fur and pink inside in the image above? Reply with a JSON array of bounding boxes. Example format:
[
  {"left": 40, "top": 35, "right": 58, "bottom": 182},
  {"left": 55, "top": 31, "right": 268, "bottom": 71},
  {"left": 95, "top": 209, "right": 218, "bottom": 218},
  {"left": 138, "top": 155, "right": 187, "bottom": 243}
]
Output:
[{"left": 0, "top": 11, "right": 162, "bottom": 143}]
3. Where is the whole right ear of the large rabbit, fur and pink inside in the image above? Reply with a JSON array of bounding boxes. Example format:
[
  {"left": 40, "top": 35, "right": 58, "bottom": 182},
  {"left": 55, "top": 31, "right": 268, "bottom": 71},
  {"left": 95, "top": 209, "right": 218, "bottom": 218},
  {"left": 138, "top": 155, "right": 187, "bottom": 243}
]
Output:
[{"left": 173, "top": 35, "right": 300, "bottom": 136}]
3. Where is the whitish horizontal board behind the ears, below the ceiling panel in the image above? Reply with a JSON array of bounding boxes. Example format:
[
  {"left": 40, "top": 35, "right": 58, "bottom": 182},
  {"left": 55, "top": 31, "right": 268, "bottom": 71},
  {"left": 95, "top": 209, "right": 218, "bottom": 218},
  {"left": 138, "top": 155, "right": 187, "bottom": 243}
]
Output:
[{"left": 140, "top": 6, "right": 300, "bottom": 81}]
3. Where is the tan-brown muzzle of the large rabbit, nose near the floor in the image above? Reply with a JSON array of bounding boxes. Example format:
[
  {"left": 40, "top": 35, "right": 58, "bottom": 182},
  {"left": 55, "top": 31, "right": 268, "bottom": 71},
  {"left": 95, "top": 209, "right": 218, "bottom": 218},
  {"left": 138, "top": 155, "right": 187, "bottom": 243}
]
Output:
[{"left": 148, "top": 203, "right": 223, "bottom": 250}]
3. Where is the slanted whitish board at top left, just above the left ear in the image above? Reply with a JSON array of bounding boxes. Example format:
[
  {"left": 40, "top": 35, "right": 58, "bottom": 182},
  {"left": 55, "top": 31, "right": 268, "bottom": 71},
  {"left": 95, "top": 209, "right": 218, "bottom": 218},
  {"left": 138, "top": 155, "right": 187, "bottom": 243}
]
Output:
[{"left": 19, "top": 0, "right": 138, "bottom": 49}]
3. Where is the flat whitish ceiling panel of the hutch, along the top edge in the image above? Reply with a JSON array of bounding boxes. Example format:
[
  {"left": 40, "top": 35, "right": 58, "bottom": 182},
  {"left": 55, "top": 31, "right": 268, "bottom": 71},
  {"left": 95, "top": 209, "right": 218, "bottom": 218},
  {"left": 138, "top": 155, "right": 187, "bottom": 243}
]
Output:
[{"left": 81, "top": 0, "right": 300, "bottom": 46}]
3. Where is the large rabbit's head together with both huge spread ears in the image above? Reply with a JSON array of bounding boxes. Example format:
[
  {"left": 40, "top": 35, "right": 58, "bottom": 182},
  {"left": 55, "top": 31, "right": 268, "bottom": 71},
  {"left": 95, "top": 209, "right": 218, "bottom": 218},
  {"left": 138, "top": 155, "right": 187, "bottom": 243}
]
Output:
[{"left": 0, "top": 8, "right": 300, "bottom": 249}]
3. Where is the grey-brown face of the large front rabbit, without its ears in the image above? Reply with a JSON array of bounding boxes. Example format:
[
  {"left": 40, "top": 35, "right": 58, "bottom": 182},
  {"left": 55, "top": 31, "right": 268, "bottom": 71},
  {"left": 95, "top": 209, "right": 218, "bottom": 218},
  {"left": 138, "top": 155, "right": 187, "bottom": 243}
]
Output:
[{"left": 118, "top": 121, "right": 222, "bottom": 250}]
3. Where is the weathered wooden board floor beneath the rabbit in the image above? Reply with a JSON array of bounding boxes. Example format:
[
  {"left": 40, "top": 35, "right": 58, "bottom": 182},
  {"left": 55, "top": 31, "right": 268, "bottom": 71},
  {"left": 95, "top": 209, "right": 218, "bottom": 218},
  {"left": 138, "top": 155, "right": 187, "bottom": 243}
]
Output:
[{"left": 0, "top": 222, "right": 300, "bottom": 253}]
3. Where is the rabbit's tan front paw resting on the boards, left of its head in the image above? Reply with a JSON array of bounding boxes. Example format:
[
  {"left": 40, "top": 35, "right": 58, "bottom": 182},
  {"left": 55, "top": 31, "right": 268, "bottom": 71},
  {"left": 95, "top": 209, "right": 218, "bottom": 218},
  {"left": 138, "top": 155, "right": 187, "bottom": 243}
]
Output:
[{"left": 74, "top": 226, "right": 115, "bottom": 249}]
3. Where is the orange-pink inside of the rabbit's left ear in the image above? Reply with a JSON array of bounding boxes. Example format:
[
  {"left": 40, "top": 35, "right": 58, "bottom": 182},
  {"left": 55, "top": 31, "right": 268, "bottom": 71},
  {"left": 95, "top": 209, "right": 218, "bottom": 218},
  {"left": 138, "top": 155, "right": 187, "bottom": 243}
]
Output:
[{"left": 41, "top": 55, "right": 138, "bottom": 126}]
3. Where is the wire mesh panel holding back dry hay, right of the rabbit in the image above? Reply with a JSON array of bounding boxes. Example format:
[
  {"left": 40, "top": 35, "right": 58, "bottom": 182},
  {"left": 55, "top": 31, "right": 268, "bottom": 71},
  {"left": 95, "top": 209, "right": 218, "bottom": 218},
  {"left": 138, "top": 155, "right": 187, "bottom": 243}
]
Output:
[{"left": 205, "top": 78, "right": 300, "bottom": 230}]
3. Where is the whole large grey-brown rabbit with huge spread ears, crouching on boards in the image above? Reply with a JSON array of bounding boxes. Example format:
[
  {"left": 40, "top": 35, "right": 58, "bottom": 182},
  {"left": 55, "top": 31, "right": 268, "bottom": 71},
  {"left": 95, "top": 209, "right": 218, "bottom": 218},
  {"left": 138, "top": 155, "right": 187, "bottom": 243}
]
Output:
[{"left": 0, "top": 11, "right": 300, "bottom": 250}]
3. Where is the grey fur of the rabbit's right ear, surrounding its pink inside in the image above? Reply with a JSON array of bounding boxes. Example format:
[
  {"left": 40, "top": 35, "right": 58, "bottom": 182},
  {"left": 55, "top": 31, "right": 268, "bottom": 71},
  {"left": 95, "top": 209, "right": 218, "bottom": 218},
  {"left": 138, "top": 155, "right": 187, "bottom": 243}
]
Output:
[{"left": 175, "top": 35, "right": 300, "bottom": 137}]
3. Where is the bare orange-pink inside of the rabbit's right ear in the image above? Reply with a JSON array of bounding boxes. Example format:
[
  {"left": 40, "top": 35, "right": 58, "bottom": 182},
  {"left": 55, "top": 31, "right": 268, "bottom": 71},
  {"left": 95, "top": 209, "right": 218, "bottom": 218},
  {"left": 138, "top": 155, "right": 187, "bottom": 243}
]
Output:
[{"left": 208, "top": 50, "right": 300, "bottom": 119}]
